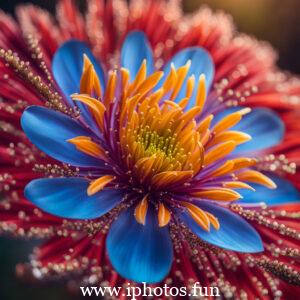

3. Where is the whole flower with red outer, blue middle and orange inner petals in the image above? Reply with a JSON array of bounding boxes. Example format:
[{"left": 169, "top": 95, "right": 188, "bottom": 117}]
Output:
[{"left": 0, "top": 1, "right": 299, "bottom": 297}]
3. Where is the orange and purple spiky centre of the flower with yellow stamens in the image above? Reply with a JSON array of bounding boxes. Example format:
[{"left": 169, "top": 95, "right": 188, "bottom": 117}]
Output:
[{"left": 69, "top": 57, "right": 275, "bottom": 230}]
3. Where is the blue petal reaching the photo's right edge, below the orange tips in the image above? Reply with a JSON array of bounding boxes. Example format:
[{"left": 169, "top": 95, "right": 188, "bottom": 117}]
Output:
[{"left": 239, "top": 174, "right": 300, "bottom": 206}]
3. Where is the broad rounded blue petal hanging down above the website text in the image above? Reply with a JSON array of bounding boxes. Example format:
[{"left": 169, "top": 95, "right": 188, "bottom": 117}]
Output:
[{"left": 106, "top": 207, "right": 173, "bottom": 283}]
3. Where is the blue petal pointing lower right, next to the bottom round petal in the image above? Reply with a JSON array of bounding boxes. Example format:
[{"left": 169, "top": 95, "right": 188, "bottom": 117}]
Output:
[{"left": 181, "top": 201, "right": 263, "bottom": 253}]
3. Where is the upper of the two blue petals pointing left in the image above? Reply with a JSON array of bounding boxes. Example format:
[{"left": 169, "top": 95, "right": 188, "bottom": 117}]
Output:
[{"left": 21, "top": 106, "right": 102, "bottom": 167}]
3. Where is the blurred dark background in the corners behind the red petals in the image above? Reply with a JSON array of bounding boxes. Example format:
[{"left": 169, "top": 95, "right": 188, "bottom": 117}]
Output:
[{"left": 0, "top": 0, "right": 300, "bottom": 300}]
